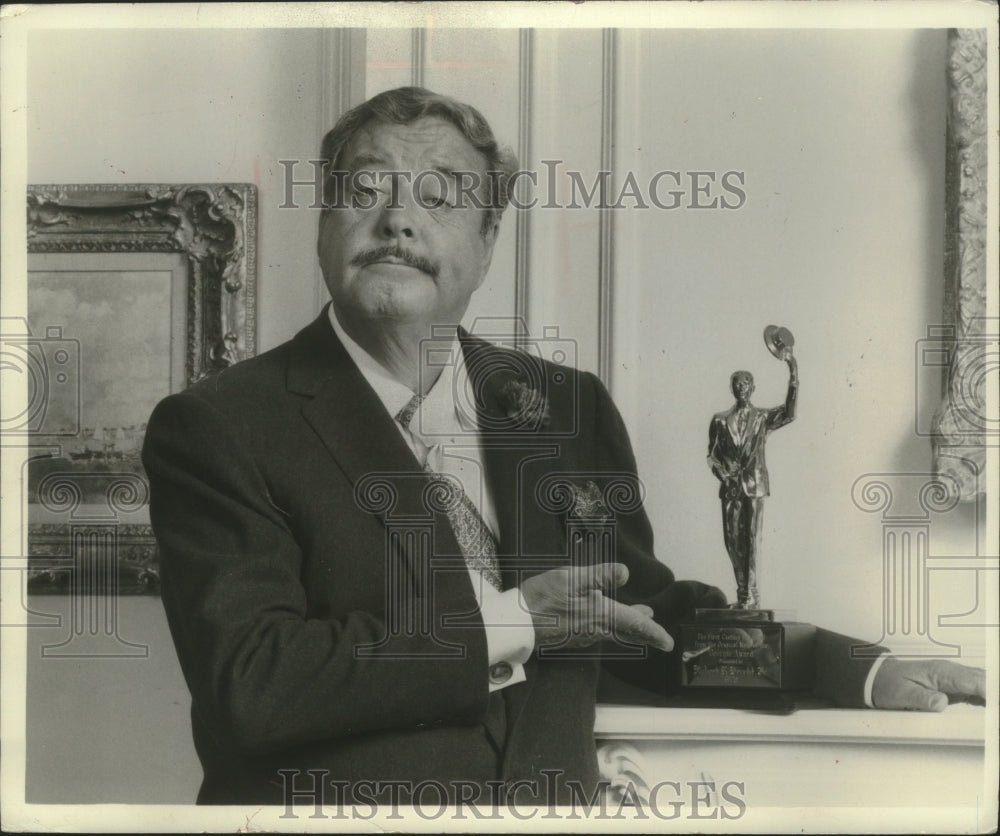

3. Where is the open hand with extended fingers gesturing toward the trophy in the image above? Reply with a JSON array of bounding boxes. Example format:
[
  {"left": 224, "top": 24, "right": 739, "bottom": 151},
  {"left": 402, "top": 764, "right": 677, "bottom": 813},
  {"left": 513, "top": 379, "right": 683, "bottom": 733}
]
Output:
[{"left": 521, "top": 563, "right": 674, "bottom": 651}]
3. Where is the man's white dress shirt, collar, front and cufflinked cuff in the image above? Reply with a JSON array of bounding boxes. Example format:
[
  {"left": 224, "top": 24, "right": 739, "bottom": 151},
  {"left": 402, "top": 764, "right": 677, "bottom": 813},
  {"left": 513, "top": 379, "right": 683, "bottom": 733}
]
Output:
[{"left": 329, "top": 305, "right": 535, "bottom": 691}]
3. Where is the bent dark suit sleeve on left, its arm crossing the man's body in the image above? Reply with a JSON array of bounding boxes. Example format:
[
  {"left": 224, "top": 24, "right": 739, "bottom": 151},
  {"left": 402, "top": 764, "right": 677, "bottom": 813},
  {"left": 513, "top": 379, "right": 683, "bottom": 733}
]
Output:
[{"left": 143, "top": 391, "right": 488, "bottom": 754}]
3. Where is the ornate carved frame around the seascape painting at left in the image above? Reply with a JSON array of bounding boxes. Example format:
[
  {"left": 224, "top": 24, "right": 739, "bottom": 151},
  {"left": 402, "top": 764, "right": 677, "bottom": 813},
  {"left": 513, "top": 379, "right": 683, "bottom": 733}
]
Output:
[{"left": 27, "top": 183, "right": 257, "bottom": 593}]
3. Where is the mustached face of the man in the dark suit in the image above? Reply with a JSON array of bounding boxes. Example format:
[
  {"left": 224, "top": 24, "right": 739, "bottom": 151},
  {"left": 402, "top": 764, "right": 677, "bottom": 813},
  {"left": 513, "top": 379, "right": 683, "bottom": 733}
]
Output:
[{"left": 318, "top": 117, "right": 497, "bottom": 329}]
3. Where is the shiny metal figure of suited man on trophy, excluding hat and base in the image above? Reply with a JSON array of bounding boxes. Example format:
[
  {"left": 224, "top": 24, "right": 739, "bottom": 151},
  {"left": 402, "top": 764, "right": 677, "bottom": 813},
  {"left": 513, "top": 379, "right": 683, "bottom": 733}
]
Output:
[{"left": 708, "top": 352, "right": 799, "bottom": 609}]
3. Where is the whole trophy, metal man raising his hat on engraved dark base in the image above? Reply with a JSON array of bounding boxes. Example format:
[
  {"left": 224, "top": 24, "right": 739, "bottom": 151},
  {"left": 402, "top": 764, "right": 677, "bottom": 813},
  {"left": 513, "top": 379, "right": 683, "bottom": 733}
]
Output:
[{"left": 680, "top": 325, "right": 816, "bottom": 705}]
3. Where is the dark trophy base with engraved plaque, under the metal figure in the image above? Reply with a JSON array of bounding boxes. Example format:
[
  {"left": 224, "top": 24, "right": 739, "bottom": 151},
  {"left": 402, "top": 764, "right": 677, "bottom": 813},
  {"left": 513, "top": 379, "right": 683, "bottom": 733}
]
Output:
[{"left": 678, "top": 609, "right": 816, "bottom": 688}]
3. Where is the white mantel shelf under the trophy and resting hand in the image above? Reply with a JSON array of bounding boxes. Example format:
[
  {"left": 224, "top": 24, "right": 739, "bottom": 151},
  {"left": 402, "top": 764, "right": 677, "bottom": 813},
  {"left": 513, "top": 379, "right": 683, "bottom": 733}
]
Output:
[{"left": 594, "top": 704, "right": 990, "bottom": 747}]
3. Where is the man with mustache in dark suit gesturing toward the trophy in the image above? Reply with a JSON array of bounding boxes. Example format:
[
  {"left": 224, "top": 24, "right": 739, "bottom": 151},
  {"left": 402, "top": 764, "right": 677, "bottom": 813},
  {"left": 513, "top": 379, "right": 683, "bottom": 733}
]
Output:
[{"left": 144, "top": 88, "right": 984, "bottom": 804}]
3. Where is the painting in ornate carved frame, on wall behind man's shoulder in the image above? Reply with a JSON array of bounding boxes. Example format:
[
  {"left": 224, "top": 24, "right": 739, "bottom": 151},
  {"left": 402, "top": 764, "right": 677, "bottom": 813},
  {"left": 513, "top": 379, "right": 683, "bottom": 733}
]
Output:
[{"left": 21, "top": 183, "right": 256, "bottom": 594}]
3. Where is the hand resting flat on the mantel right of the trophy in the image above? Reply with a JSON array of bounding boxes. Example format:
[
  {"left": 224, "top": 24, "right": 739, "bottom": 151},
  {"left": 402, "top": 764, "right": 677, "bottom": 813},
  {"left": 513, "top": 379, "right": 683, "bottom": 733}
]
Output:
[{"left": 872, "top": 659, "right": 986, "bottom": 711}]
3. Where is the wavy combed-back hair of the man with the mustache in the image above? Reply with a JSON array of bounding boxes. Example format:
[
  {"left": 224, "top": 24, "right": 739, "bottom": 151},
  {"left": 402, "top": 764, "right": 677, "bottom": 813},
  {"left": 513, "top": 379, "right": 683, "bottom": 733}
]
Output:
[{"left": 320, "top": 87, "right": 517, "bottom": 234}]
